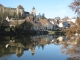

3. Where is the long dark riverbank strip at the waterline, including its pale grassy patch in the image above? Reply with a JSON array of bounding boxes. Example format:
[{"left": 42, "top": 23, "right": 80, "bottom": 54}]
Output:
[{"left": 0, "top": 30, "right": 64, "bottom": 36}]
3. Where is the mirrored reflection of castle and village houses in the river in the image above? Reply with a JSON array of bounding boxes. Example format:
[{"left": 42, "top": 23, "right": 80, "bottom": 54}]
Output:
[{"left": 0, "top": 35, "right": 67, "bottom": 57}]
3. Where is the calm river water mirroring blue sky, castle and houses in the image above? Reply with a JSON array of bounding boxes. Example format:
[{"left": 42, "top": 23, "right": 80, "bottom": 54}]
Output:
[{"left": 0, "top": 35, "right": 75, "bottom": 60}]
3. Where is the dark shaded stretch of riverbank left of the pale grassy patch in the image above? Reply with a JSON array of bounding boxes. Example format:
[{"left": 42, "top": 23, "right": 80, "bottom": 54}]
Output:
[{"left": 0, "top": 30, "right": 48, "bottom": 36}]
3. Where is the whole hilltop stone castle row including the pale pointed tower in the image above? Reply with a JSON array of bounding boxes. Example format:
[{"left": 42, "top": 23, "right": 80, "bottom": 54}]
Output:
[{"left": 0, "top": 4, "right": 36, "bottom": 17}]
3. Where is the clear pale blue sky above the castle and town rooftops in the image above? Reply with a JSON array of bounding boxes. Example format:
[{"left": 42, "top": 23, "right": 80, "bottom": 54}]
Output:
[{"left": 0, "top": 0, "right": 76, "bottom": 18}]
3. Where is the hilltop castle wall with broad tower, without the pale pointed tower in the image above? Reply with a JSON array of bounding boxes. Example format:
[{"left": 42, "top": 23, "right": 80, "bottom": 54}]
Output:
[{"left": 0, "top": 4, "right": 24, "bottom": 16}]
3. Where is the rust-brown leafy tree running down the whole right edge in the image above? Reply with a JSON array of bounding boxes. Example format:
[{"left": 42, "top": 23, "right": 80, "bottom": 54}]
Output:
[{"left": 62, "top": 0, "right": 80, "bottom": 60}]
